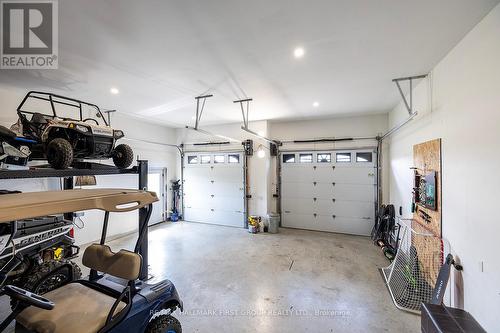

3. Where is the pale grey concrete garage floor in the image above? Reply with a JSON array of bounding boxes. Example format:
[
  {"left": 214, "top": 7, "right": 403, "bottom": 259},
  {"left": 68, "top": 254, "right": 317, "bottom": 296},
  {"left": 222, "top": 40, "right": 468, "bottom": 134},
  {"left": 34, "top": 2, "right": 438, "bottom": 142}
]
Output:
[{"left": 2, "top": 222, "right": 420, "bottom": 333}]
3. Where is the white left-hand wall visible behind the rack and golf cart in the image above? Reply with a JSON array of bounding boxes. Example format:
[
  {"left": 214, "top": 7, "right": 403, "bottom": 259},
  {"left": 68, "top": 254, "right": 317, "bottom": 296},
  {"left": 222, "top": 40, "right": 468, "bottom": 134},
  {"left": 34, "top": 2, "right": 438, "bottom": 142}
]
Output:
[{"left": 0, "top": 86, "right": 178, "bottom": 244}]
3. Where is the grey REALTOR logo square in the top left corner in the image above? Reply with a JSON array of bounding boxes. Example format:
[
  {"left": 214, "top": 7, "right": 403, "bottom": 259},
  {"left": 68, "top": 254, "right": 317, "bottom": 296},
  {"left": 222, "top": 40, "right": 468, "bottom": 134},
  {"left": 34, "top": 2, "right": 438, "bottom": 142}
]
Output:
[{"left": 0, "top": 0, "right": 58, "bottom": 69}]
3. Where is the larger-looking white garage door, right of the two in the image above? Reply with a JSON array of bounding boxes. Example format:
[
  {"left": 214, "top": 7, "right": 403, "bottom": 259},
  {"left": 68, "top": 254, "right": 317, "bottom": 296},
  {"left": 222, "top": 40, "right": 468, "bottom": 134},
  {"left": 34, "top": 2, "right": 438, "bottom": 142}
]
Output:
[{"left": 281, "top": 150, "right": 376, "bottom": 235}]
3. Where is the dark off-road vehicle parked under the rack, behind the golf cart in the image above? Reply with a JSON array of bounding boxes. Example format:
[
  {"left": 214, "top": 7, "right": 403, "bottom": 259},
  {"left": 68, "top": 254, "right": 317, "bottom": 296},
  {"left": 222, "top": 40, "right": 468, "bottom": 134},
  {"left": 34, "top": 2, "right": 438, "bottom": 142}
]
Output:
[{"left": 0, "top": 191, "right": 81, "bottom": 304}]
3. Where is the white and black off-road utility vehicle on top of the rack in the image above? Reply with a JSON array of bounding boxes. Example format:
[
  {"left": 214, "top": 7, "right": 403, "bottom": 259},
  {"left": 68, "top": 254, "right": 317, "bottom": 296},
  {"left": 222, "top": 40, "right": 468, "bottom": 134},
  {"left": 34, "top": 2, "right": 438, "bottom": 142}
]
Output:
[{"left": 13, "top": 91, "right": 134, "bottom": 169}]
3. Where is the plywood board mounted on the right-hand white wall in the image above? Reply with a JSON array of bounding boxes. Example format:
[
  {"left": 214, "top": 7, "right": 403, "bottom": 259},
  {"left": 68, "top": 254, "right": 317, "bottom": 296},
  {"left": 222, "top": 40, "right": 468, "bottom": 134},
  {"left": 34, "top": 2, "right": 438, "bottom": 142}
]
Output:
[{"left": 413, "top": 139, "right": 442, "bottom": 237}]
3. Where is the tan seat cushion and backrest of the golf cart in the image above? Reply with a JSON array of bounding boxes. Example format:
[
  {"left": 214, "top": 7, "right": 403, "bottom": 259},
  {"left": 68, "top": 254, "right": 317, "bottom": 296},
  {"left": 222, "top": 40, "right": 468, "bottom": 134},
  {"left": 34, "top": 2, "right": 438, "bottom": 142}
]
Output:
[{"left": 16, "top": 244, "right": 142, "bottom": 333}]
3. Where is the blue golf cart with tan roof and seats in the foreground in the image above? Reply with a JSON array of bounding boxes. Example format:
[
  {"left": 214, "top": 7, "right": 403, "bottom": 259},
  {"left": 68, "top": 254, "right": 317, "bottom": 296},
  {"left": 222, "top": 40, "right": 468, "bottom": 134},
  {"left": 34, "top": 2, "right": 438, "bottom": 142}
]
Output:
[{"left": 0, "top": 189, "right": 183, "bottom": 333}]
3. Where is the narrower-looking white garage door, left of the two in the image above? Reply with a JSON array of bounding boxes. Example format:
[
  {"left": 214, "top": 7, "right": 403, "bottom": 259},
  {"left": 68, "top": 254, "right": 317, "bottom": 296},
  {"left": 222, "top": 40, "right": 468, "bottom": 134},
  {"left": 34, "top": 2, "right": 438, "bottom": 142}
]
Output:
[{"left": 184, "top": 153, "right": 245, "bottom": 227}]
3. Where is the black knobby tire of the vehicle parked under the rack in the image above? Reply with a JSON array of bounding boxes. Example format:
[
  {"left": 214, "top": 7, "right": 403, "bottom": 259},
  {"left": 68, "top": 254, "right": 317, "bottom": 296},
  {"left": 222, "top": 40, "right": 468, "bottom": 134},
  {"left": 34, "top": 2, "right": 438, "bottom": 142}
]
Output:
[{"left": 11, "top": 259, "right": 82, "bottom": 308}]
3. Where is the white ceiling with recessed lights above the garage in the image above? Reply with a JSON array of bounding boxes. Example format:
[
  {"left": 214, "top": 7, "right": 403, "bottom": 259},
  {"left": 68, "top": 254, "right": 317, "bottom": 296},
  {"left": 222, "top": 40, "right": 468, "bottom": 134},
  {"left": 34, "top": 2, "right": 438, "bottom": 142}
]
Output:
[{"left": 0, "top": 0, "right": 500, "bottom": 126}]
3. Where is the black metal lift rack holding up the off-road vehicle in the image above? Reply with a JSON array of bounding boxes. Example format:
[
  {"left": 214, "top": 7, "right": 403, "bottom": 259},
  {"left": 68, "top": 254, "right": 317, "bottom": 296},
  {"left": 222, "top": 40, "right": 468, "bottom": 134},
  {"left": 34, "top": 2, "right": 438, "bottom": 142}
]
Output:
[{"left": 0, "top": 160, "right": 148, "bottom": 280}]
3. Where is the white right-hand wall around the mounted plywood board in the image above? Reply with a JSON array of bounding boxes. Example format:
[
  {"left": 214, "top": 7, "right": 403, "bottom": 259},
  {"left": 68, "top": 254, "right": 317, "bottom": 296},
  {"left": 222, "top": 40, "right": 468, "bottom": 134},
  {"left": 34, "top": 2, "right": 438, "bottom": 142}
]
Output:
[{"left": 390, "top": 5, "right": 500, "bottom": 332}]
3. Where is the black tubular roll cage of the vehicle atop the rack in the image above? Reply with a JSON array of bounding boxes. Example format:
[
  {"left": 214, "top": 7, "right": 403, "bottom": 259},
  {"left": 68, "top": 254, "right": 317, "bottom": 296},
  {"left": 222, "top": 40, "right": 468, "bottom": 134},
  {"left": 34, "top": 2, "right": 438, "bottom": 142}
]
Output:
[{"left": 17, "top": 91, "right": 109, "bottom": 126}]
